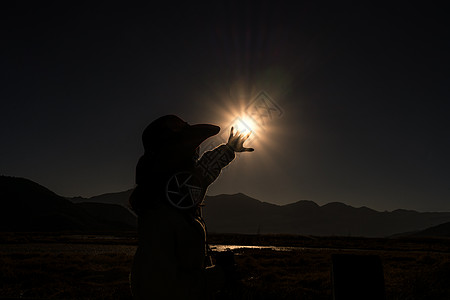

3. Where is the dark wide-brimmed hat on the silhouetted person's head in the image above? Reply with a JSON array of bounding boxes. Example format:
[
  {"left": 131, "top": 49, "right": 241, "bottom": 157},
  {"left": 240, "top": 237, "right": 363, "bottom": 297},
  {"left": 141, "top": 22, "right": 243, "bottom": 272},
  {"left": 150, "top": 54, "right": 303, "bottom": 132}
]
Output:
[{"left": 142, "top": 115, "right": 220, "bottom": 152}]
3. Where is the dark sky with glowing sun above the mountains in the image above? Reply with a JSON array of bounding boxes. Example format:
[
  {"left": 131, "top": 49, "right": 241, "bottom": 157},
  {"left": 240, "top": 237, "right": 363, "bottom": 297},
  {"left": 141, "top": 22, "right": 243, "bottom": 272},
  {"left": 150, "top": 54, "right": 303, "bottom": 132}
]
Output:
[{"left": 0, "top": 1, "right": 450, "bottom": 211}]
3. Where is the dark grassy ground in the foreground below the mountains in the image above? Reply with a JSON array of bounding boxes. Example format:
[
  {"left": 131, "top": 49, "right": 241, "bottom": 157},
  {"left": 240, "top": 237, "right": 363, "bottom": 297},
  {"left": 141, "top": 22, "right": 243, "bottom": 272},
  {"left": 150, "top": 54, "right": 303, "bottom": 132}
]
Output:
[{"left": 0, "top": 233, "right": 450, "bottom": 299}]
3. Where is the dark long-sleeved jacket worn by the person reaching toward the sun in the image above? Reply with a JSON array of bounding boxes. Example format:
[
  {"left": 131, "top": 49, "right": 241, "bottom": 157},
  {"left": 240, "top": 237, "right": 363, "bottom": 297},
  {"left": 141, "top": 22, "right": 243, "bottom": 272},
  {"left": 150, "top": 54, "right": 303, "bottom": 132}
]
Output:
[{"left": 131, "top": 145, "right": 235, "bottom": 299}]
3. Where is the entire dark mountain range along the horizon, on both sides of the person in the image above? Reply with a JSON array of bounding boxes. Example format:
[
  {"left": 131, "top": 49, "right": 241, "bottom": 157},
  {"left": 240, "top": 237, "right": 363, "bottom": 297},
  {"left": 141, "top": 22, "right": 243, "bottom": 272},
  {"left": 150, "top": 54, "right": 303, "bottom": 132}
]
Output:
[{"left": 0, "top": 176, "right": 450, "bottom": 237}]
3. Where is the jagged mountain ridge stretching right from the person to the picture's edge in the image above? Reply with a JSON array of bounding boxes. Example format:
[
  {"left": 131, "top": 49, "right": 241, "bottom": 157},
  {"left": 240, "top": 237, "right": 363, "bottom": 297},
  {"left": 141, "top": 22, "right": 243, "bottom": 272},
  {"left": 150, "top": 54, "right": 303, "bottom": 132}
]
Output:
[{"left": 203, "top": 194, "right": 450, "bottom": 237}]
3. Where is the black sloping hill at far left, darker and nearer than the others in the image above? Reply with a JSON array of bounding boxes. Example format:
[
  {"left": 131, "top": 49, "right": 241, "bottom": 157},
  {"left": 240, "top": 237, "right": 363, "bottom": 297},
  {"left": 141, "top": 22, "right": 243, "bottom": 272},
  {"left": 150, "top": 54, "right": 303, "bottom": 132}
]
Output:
[{"left": 0, "top": 176, "right": 136, "bottom": 231}]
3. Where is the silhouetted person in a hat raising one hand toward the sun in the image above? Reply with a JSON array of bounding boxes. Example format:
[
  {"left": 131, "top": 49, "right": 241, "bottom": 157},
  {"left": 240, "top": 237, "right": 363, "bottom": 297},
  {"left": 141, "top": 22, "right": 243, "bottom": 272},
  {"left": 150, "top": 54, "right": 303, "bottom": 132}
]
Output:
[{"left": 130, "top": 115, "right": 253, "bottom": 299}]
